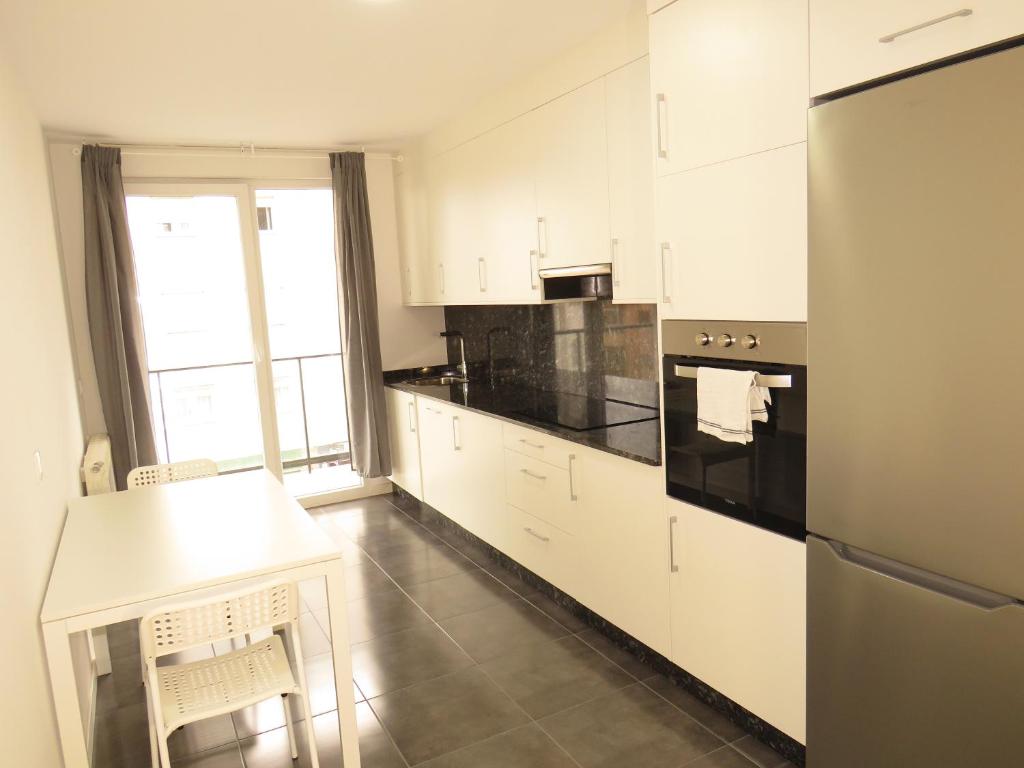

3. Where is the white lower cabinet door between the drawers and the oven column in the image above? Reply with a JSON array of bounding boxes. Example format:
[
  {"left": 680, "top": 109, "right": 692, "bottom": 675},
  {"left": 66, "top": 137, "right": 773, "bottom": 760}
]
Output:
[{"left": 573, "top": 449, "right": 671, "bottom": 656}]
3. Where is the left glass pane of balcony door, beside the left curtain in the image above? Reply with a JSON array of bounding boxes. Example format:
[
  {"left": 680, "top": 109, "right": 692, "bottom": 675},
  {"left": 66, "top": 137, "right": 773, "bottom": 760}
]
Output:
[{"left": 127, "top": 191, "right": 264, "bottom": 472}]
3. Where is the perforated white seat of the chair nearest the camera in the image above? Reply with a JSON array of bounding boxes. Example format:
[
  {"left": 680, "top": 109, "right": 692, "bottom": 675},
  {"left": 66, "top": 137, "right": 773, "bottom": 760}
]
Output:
[{"left": 157, "top": 635, "right": 299, "bottom": 733}]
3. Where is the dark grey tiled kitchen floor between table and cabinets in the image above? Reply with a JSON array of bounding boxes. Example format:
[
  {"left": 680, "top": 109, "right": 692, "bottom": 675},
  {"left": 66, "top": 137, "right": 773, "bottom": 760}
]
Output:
[{"left": 95, "top": 497, "right": 791, "bottom": 768}]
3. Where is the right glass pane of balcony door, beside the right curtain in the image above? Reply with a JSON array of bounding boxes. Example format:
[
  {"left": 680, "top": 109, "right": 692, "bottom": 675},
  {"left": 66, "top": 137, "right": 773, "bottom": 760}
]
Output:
[{"left": 256, "top": 189, "right": 360, "bottom": 496}]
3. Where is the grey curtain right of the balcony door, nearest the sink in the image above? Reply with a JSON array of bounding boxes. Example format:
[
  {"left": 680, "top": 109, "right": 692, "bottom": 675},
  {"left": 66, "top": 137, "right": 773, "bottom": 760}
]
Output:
[{"left": 331, "top": 152, "right": 391, "bottom": 477}]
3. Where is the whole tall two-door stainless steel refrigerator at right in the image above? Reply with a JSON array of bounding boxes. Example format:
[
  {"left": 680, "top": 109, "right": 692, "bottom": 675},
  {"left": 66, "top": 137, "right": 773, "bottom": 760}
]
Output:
[{"left": 807, "top": 47, "right": 1024, "bottom": 768}]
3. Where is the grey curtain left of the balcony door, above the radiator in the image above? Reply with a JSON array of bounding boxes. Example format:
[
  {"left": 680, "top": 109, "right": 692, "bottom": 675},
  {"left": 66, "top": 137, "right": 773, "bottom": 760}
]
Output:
[{"left": 82, "top": 146, "right": 157, "bottom": 488}]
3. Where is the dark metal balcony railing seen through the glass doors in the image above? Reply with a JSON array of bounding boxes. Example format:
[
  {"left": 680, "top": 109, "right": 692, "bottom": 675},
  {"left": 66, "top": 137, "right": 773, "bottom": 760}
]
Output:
[{"left": 150, "top": 352, "right": 351, "bottom": 473}]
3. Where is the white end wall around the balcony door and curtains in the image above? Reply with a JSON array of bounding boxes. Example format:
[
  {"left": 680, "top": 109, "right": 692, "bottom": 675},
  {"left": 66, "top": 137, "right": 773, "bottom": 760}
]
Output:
[{"left": 49, "top": 139, "right": 445, "bottom": 434}]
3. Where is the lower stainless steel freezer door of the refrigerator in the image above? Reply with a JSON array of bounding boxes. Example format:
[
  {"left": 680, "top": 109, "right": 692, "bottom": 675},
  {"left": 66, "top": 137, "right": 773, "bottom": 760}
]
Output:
[{"left": 807, "top": 537, "right": 1024, "bottom": 768}]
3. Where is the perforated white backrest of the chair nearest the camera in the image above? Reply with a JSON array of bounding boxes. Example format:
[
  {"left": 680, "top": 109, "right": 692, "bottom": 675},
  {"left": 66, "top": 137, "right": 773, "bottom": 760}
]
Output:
[{"left": 139, "top": 581, "right": 299, "bottom": 659}]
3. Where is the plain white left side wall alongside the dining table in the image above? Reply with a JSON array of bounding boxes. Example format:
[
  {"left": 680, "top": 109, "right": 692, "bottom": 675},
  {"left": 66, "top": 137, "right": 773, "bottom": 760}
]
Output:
[{"left": 0, "top": 62, "right": 83, "bottom": 768}]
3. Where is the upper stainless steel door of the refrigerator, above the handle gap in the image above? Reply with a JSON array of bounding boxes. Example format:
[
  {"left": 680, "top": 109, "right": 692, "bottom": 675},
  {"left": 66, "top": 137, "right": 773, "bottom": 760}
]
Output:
[{"left": 807, "top": 47, "right": 1024, "bottom": 597}]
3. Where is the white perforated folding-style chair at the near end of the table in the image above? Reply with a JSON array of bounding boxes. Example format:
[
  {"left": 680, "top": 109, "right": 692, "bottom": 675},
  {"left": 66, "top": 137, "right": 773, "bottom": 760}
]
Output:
[{"left": 139, "top": 582, "right": 319, "bottom": 768}]
